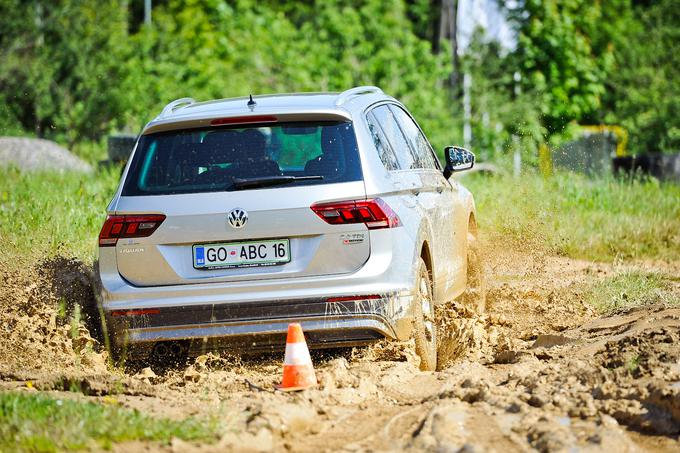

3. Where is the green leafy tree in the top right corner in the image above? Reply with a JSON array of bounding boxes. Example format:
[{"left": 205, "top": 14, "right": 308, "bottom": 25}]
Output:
[{"left": 603, "top": 0, "right": 680, "bottom": 153}]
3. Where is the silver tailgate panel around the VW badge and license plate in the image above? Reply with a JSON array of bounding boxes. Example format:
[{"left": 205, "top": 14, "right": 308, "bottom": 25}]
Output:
[{"left": 116, "top": 181, "right": 370, "bottom": 286}]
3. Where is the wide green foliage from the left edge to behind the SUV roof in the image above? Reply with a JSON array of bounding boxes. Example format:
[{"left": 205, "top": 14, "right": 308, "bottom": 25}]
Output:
[{"left": 0, "top": 0, "right": 440, "bottom": 146}]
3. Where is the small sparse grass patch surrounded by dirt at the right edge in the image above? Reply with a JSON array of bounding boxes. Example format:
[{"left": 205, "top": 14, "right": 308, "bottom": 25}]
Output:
[{"left": 585, "top": 270, "right": 680, "bottom": 314}]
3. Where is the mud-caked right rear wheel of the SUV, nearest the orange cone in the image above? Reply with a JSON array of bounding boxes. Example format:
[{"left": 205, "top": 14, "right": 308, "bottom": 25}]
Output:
[{"left": 413, "top": 258, "right": 437, "bottom": 371}]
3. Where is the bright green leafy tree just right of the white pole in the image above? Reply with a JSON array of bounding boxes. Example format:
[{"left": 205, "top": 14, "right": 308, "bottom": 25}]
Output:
[{"left": 512, "top": 0, "right": 612, "bottom": 133}]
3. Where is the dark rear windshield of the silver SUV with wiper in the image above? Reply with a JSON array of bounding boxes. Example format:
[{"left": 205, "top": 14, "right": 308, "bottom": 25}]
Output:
[{"left": 122, "top": 121, "right": 361, "bottom": 196}]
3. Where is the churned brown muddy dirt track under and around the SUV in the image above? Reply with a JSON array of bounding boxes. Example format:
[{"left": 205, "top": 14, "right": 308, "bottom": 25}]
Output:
[{"left": 0, "top": 240, "right": 680, "bottom": 452}]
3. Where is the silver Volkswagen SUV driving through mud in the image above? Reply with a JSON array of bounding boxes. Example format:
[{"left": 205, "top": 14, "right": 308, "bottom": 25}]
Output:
[{"left": 99, "top": 87, "right": 475, "bottom": 369}]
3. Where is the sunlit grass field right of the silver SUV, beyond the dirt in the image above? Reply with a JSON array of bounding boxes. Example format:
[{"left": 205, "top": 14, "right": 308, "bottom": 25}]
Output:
[{"left": 463, "top": 170, "right": 680, "bottom": 261}]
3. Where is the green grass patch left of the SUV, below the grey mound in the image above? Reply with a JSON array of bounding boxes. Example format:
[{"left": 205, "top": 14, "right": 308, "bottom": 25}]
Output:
[{"left": 0, "top": 167, "right": 120, "bottom": 262}]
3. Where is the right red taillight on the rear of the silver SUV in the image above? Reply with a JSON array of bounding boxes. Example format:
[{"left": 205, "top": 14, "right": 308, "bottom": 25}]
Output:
[{"left": 311, "top": 198, "right": 401, "bottom": 230}]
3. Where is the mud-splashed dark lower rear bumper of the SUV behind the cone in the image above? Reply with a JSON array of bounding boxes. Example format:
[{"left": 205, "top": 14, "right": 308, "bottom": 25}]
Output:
[{"left": 105, "top": 292, "right": 411, "bottom": 352}]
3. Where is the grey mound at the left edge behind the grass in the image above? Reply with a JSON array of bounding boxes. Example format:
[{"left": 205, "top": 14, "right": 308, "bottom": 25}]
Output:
[{"left": 0, "top": 137, "right": 92, "bottom": 172}]
